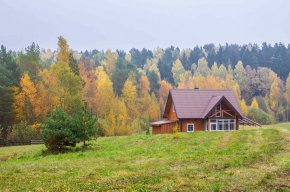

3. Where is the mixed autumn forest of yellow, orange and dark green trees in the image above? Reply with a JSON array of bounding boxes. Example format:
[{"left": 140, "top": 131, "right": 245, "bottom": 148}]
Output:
[{"left": 0, "top": 36, "right": 290, "bottom": 144}]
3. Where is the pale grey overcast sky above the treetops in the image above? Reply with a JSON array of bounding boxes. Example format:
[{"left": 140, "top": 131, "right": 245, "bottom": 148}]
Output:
[{"left": 0, "top": 0, "right": 290, "bottom": 50}]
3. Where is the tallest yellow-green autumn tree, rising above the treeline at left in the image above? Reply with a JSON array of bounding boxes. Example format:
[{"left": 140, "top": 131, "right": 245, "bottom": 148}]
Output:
[{"left": 39, "top": 37, "right": 82, "bottom": 114}]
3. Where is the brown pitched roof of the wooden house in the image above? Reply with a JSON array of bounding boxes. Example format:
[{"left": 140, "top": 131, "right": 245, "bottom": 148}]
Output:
[{"left": 169, "top": 89, "right": 242, "bottom": 118}]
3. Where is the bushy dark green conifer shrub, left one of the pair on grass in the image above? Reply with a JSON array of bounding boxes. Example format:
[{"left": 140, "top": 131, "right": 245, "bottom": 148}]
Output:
[{"left": 42, "top": 108, "right": 79, "bottom": 152}]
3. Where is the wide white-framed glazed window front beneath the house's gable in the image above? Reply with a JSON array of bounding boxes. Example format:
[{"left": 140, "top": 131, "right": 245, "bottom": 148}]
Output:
[{"left": 209, "top": 119, "right": 236, "bottom": 131}]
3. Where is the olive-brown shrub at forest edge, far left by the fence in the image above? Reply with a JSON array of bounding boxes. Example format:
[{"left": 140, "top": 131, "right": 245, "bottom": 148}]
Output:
[{"left": 8, "top": 123, "right": 39, "bottom": 144}]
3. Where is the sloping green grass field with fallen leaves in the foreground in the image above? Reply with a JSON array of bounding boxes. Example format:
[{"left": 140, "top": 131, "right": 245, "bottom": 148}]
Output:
[{"left": 0, "top": 123, "right": 290, "bottom": 191}]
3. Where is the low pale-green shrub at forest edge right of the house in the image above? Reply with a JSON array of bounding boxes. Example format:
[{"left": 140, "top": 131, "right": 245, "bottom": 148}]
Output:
[{"left": 247, "top": 108, "right": 275, "bottom": 124}]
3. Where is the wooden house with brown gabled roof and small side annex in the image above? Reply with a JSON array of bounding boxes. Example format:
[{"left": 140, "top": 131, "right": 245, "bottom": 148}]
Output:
[{"left": 151, "top": 89, "right": 243, "bottom": 134}]
